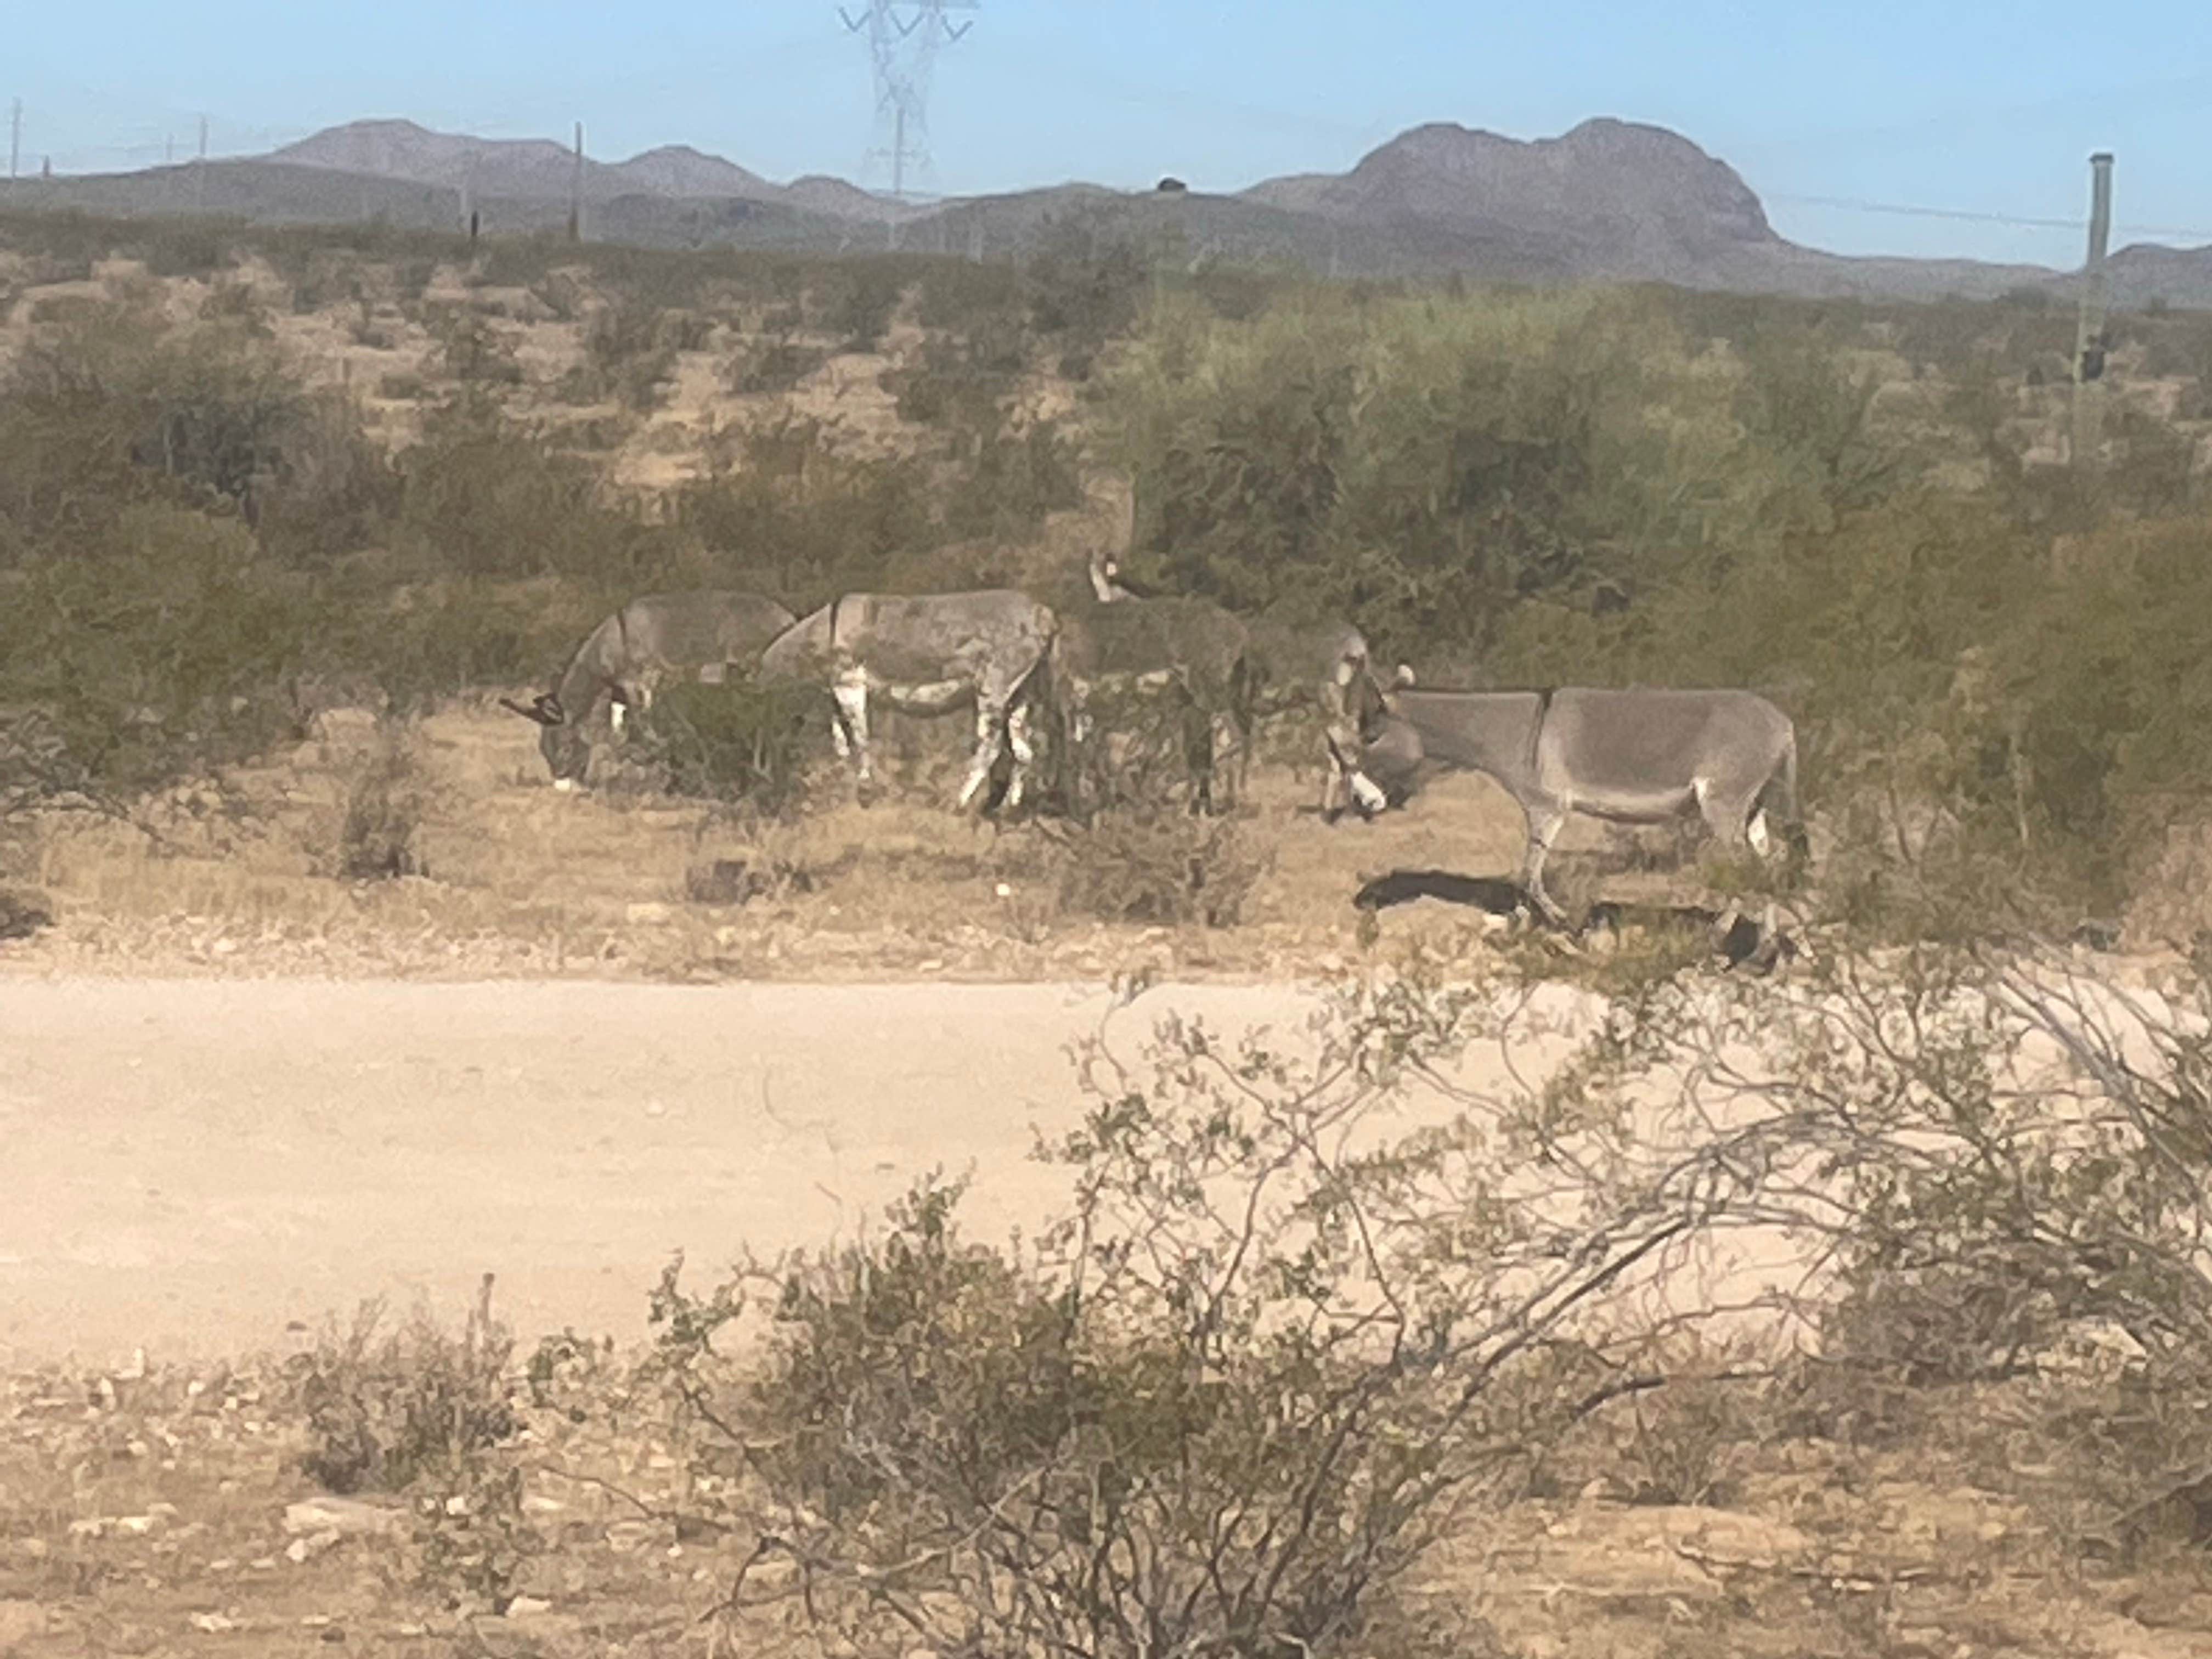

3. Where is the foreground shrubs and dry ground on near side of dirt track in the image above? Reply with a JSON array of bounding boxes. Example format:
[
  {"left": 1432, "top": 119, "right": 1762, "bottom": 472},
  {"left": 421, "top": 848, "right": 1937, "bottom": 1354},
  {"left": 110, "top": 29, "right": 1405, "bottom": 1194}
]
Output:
[{"left": 13, "top": 947, "right": 2212, "bottom": 1655}]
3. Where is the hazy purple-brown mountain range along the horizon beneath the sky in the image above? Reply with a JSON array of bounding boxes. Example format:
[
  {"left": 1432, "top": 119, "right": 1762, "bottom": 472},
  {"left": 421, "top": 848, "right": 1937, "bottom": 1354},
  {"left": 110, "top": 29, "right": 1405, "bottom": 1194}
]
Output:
[{"left": 0, "top": 117, "right": 2212, "bottom": 307}]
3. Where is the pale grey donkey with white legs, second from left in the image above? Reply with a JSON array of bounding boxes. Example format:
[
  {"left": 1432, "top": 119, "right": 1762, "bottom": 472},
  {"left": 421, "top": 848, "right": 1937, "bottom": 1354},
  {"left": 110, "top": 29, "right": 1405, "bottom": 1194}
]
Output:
[{"left": 761, "top": 589, "right": 1059, "bottom": 812}]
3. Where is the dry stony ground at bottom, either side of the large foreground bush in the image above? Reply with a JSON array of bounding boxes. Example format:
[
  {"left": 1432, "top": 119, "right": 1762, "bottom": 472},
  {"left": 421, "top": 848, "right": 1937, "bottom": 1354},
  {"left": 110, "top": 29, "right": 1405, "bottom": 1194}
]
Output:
[{"left": 0, "top": 1342, "right": 2212, "bottom": 1659}]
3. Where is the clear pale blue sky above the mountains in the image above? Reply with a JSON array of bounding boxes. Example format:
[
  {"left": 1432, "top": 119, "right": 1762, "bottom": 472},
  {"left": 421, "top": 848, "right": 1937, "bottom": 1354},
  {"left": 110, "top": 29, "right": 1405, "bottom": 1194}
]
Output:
[{"left": 13, "top": 0, "right": 2212, "bottom": 266}]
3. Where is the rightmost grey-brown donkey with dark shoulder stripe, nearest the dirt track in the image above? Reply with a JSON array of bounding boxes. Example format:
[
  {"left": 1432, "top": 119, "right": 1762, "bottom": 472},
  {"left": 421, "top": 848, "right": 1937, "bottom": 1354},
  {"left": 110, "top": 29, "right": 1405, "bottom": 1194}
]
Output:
[{"left": 1361, "top": 668, "right": 1805, "bottom": 924}]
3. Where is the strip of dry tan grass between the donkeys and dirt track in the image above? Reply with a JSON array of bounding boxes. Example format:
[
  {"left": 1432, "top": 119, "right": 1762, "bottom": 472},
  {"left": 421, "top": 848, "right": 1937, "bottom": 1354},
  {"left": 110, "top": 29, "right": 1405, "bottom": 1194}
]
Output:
[{"left": 0, "top": 690, "right": 1716, "bottom": 980}]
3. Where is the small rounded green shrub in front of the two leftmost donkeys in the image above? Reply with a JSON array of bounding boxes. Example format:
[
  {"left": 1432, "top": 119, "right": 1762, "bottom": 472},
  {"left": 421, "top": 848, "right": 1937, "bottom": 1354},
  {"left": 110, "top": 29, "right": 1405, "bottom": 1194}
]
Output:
[{"left": 639, "top": 675, "right": 827, "bottom": 816}]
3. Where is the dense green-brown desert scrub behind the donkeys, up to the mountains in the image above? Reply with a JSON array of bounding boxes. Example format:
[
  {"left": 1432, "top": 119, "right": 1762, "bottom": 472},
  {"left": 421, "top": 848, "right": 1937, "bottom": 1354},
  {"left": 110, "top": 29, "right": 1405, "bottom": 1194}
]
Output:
[{"left": 0, "top": 215, "right": 2212, "bottom": 969}]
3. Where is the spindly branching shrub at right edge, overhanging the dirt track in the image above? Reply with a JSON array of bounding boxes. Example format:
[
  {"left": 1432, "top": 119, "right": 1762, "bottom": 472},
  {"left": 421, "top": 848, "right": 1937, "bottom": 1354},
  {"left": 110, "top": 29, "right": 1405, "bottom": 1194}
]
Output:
[{"left": 1573, "top": 936, "right": 2212, "bottom": 1511}]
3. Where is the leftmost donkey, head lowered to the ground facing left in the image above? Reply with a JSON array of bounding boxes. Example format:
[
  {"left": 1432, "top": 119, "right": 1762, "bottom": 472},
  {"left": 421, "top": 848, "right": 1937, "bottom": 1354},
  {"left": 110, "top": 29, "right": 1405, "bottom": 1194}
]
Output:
[{"left": 500, "top": 589, "right": 792, "bottom": 789}]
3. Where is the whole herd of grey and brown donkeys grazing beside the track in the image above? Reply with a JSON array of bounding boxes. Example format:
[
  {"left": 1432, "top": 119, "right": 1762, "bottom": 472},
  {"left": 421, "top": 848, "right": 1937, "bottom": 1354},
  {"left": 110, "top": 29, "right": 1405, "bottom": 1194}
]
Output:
[{"left": 500, "top": 541, "right": 1805, "bottom": 924}]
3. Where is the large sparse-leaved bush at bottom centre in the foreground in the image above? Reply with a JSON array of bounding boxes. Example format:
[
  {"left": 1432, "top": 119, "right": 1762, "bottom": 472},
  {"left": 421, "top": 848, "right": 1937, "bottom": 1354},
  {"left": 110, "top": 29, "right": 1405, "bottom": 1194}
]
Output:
[{"left": 654, "top": 986, "right": 1778, "bottom": 1657}]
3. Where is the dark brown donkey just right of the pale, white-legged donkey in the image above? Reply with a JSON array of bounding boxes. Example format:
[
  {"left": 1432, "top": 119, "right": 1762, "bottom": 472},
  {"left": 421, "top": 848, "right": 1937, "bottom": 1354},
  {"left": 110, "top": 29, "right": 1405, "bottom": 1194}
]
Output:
[{"left": 1053, "top": 555, "right": 1252, "bottom": 812}]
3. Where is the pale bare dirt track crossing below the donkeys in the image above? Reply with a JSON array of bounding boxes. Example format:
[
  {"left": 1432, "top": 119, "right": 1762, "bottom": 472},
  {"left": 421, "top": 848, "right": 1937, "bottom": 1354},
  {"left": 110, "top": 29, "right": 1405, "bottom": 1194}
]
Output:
[{"left": 0, "top": 980, "right": 1345, "bottom": 1365}]
